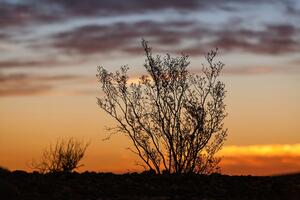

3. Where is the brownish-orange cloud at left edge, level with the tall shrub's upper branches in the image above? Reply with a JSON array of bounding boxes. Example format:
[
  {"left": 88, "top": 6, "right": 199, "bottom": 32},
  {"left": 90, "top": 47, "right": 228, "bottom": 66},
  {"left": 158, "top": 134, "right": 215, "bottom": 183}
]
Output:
[{"left": 0, "top": 73, "right": 88, "bottom": 97}]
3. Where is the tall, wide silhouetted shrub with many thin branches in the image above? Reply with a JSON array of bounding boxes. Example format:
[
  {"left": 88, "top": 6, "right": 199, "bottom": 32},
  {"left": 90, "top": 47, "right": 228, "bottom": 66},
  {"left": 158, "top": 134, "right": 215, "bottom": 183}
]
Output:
[{"left": 97, "top": 40, "right": 227, "bottom": 174}]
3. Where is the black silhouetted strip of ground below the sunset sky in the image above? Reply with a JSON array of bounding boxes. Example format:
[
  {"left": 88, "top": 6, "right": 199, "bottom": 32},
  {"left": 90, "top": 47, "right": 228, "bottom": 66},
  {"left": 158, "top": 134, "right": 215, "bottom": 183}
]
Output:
[{"left": 0, "top": 171, "right": 300, "bottom": 200}]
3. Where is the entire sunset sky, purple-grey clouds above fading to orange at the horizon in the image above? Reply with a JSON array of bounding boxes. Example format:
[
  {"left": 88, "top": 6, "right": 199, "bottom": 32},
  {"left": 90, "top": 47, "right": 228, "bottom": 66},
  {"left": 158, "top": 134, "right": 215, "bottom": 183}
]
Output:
[{"left": 0, "top": 0, "right": 300, "bottom": 175}]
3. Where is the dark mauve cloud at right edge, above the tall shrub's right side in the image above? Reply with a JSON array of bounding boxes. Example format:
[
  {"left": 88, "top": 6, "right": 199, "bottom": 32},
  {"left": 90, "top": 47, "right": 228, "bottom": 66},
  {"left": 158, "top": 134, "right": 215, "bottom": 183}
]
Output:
[{"left": 210, "top": 25, "right": 300, "bottom": 54}]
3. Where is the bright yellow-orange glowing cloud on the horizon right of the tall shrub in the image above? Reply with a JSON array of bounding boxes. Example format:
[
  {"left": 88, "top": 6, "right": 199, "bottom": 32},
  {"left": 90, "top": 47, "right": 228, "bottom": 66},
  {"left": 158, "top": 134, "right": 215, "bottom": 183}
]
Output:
[{"left": 220, "top": 144, "right": 300, "bottom": 175}]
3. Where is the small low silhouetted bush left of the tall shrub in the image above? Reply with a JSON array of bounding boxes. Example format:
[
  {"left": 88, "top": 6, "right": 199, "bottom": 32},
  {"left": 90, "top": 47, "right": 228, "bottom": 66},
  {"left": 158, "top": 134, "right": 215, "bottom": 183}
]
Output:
[{"left": 32, "top": 138, "right": 89, "bottom": 173}]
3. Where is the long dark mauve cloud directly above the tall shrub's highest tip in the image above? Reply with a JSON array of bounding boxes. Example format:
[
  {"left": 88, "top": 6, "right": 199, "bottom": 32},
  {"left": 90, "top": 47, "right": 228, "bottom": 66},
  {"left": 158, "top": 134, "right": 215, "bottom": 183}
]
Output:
[{"left": 53, "top": 21, "right": 197, "bottom": 54}]
